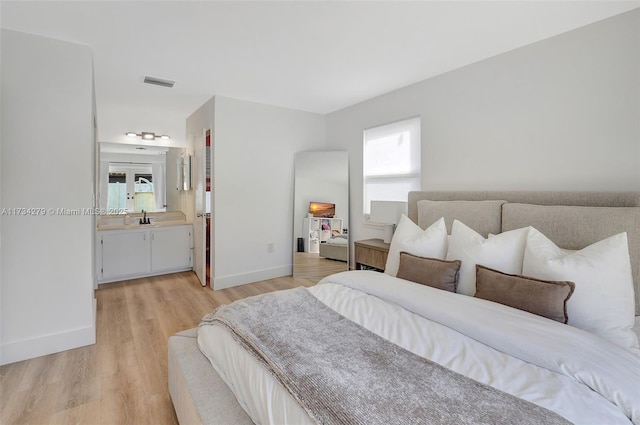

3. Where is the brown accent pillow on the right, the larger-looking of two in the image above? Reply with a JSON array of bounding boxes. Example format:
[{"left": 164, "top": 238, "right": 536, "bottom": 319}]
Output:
[{"left": 474, "top": 264, "right": 576, "bottom": 323}]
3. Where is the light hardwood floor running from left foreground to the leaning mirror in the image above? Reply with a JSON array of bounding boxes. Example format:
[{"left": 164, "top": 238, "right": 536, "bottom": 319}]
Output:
[{"left": 0, "top": 272, "right": 317, "bottom": 425}]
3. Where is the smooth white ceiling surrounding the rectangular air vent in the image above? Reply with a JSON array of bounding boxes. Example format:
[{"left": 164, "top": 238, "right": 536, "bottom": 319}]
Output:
[{"left": 0, "top": 0, "right": 640, "bottom": 146}]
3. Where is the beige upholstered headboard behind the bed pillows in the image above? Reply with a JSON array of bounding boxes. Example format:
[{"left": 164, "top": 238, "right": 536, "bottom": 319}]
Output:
[{"left": 408, "top": 191, "right": 640, "bottom": 315}]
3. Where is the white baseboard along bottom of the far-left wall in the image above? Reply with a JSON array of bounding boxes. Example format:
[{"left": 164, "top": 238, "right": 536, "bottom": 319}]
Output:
[{"left": 0, "top": 323, "right": 96, "bottom": 365}]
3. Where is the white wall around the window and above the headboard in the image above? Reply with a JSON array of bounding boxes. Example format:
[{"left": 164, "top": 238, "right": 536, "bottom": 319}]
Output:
[{"left": 326, "top": 9, "right": 640, "bottom": 245}]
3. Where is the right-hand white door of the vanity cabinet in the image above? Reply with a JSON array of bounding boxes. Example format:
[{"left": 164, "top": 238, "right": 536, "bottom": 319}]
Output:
[{"left": 151, "top": 226, "right": 192, "bottom": 272}]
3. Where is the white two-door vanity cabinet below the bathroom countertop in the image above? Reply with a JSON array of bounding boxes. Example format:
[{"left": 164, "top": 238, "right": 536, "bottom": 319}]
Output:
[{"left": 96, "top": 224, "right": 193, "bottom": 283}]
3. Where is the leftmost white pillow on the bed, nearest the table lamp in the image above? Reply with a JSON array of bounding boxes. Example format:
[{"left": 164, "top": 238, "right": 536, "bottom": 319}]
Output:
[{"left": 384, "top": 214, "right": 447, "bottom": 276}]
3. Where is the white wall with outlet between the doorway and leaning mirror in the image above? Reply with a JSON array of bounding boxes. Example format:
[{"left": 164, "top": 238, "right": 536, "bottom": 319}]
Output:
[{"left": 212, "top": 96, "right": 325, "bottom": 289}]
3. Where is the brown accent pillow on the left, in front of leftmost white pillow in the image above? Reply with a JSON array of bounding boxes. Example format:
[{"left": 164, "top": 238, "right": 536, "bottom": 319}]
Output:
[{"left": 396, "top": 252, "right": 461, "bottom": 292}]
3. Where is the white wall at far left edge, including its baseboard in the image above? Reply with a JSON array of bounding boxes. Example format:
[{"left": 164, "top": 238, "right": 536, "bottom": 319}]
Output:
[{"left": 0, "top": 30, "right": 95, "bottom": 364}]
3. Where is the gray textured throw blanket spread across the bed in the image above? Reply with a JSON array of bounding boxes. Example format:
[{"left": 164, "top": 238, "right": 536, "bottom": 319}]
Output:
[{"left": 200, "top": 287, "right": 569, "bottom": 425}]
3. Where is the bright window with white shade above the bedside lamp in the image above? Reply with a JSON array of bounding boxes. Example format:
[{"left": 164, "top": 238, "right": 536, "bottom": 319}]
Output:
[{"left": 364, "top": 118, "right": 421, "bottom": 220}]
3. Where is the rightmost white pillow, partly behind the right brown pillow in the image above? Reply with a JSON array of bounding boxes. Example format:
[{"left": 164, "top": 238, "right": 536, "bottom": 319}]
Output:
[{"left": 522, "top": 229, "right": 638, "bottom": 348}]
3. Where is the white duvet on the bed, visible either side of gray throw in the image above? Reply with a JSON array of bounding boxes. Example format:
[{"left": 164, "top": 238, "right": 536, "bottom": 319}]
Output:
[{"left": 198, "top": 271, "right": 640, "bottom": 425}]
